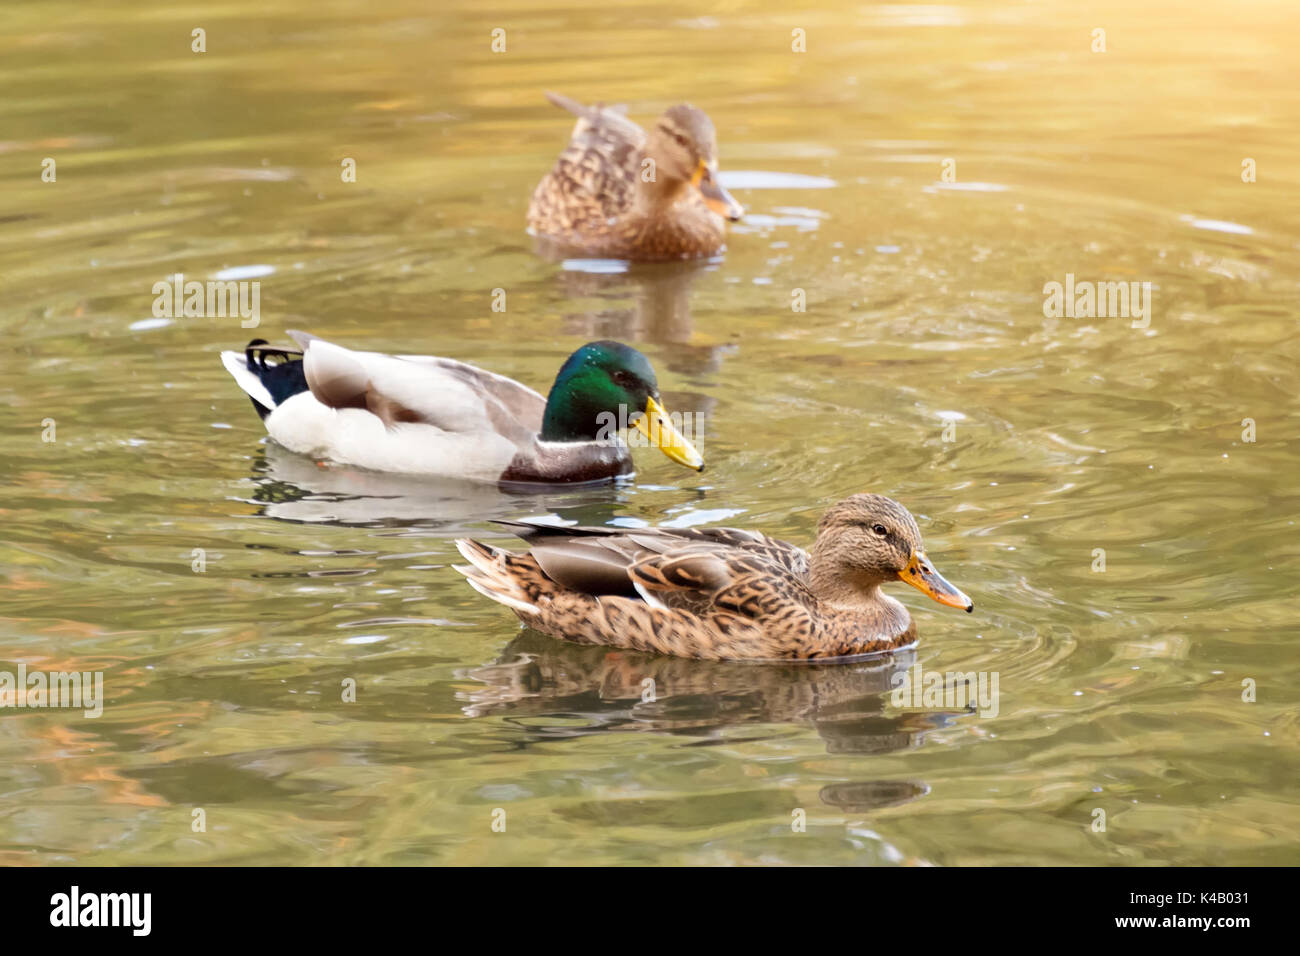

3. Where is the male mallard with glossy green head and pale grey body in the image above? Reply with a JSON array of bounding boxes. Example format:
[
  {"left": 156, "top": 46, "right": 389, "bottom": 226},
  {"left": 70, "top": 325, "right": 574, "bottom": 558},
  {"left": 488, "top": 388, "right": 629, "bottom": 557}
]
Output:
[{"left": 221, "top": 332, "right": 705, "bottom": 483}]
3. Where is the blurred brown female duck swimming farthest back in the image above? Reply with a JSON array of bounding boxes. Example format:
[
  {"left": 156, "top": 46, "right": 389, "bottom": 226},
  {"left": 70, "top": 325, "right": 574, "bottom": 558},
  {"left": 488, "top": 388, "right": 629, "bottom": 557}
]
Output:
[{"left": 528, "top": 92, "right": 744, "bottom": 261}]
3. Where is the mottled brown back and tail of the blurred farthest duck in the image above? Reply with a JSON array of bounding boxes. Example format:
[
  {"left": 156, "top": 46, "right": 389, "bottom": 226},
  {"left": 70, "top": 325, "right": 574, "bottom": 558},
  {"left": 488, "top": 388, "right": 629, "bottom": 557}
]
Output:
[{"left": 528, "top": 94, "right": 645, "bottom": 237}]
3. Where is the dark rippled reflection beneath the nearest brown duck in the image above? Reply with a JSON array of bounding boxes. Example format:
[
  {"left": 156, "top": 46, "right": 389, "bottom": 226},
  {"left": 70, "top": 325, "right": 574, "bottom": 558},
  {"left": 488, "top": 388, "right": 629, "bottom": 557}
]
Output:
[{"left": 456, "top": 630, "right": 962, "bottom": 810}]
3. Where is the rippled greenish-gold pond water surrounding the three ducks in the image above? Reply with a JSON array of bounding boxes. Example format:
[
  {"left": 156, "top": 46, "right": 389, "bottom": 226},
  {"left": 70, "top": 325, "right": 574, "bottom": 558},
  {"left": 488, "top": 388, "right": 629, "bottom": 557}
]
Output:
[{"left": 0, "top": 0, "right": 1300, "bottom": 864}]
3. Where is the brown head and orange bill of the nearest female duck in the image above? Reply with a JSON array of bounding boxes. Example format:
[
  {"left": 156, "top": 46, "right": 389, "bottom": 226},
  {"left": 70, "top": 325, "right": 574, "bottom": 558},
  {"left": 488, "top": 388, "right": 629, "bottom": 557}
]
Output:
[{"left": 810, "top": 494, "right": 975, "bottom": 611}]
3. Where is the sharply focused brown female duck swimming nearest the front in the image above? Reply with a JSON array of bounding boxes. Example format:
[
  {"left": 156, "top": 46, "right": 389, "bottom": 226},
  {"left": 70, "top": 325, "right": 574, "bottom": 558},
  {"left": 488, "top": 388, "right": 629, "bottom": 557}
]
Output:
[{"left": 455, "top": 494, "right": 975, "bottom": 659}]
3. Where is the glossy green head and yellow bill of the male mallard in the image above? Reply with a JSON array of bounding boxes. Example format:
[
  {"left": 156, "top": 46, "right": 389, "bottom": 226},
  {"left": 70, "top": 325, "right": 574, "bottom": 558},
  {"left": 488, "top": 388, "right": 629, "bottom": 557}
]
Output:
[{"left": 542, "top": 341, "right": 705, "bottom": 471}]
